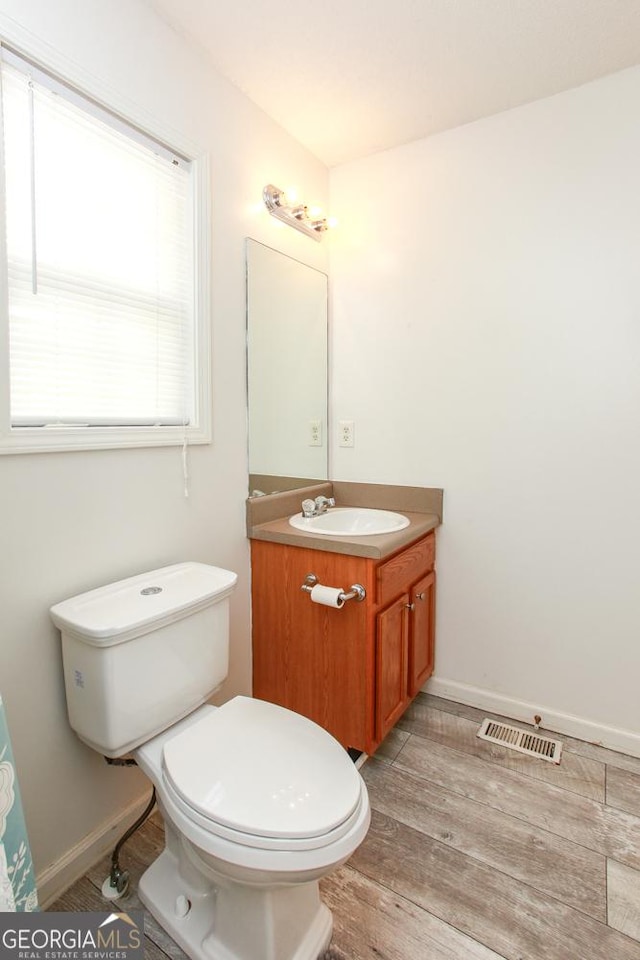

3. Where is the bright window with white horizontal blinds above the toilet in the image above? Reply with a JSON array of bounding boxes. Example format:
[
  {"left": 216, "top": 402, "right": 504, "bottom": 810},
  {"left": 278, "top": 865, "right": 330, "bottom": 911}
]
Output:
[{"left": 0, "top": 48, "right": 208, "bottom": 452}]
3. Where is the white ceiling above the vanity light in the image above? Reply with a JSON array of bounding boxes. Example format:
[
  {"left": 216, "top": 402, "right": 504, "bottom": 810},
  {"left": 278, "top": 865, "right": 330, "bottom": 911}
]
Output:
[{"left": 148, "top": 0, "right": 640, "bottom": 166}]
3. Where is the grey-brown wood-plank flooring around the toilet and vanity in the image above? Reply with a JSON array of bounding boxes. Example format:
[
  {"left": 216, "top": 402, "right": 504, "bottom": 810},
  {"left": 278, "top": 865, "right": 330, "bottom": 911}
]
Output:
[{"left": 51, "top": 694, "right": 640, "bottom": 960}]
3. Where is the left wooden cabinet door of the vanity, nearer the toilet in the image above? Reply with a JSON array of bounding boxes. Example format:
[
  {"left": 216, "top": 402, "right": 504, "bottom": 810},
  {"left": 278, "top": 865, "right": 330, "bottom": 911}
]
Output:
[{"left": 376, "top": 594, "right": 409, "bottom": 741}]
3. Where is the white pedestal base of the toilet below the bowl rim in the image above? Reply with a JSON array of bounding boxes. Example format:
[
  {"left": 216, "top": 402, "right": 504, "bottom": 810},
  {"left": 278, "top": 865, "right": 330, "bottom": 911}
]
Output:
[{"left": 138, "top": 847, "right": 333, "bottom": 960}]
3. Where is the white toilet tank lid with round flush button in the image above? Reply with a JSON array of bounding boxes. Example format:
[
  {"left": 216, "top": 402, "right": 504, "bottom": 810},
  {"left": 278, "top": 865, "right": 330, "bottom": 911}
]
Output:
[{"left": 50, "top": 561, "right": 238, "bottom": 646}]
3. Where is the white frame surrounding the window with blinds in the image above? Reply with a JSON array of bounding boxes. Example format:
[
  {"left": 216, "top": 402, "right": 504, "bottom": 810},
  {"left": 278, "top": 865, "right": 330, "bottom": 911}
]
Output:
[{"left": 0, "top": 38, "right": 211, "bottom": 455}]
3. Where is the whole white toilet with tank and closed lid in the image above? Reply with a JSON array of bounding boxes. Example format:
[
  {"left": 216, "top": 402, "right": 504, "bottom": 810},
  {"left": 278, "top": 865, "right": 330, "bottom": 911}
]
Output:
[{"left": 51, "top": 563, "right": 370, "bottom": 960}]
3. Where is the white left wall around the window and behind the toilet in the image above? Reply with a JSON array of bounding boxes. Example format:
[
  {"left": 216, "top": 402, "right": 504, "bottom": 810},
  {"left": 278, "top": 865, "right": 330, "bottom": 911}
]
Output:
[{"left": 0, "top": 0, "right": 328, "bottom": 885}]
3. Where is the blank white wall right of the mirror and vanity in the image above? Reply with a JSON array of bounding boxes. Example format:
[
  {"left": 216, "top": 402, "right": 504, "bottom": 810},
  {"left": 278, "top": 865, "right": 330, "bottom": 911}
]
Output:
[{"left": 331, "top": 68, "right": 640, "bottom": 752}]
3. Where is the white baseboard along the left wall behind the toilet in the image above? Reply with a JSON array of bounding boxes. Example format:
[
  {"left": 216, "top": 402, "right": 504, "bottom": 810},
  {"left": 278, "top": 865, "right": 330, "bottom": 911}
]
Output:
[{"left": 36, "top": 797, "right": 149, "bottom": 910}]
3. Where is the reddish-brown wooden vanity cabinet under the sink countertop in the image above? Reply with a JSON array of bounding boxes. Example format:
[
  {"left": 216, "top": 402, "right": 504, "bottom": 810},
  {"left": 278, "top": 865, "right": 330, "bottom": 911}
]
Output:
[{"left": 251, "top": 533, "right": 435, "bottom": 753}]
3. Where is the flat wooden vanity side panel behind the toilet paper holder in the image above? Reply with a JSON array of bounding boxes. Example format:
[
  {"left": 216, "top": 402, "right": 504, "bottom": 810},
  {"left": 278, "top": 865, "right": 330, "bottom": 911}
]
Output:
[{"left": 251, "top": 540, "right": 375, "bottom": 753}]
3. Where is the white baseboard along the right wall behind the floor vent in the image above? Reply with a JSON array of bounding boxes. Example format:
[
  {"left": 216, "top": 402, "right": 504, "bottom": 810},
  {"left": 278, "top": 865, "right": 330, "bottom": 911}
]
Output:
[{"left": 422, "top": 677, "right": 640, "bottom": 757}]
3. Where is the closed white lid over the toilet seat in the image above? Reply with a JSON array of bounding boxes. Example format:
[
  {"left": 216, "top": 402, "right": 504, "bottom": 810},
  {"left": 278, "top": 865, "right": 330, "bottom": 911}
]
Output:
[{"left": 163, "top": 697, "right": 361, "bottom": 839}]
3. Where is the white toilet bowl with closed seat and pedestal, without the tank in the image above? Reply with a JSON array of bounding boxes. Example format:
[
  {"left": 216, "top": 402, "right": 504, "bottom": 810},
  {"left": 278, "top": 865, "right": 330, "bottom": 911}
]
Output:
[{"left": 135, "top": 697, "right": 370, "bottom": 960}]
